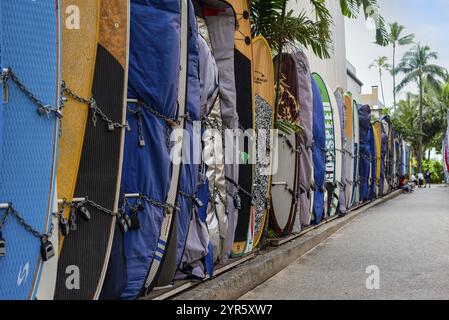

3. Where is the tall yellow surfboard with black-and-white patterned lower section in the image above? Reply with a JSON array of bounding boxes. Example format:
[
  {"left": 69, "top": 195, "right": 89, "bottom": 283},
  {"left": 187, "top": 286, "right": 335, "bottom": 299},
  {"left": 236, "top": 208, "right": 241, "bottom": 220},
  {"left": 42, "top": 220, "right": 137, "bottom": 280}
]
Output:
[{"left": 253, "top": 36, "right": 275, "bottom": 248}]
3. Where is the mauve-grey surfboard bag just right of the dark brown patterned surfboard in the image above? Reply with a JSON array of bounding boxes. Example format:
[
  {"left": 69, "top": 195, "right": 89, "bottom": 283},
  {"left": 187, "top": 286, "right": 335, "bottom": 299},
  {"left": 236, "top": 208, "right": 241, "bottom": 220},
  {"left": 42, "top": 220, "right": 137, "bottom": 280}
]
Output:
[{"left": 293, "top": 51, "right": 313, "bottom": 227}]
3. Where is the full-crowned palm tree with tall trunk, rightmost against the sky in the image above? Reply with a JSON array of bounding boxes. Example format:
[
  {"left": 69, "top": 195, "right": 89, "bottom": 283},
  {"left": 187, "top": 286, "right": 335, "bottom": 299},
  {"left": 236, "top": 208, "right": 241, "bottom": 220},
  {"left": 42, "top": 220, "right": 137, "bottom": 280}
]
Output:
[{"left": 396, "top": 44, "right": 447, "bottom": 171}]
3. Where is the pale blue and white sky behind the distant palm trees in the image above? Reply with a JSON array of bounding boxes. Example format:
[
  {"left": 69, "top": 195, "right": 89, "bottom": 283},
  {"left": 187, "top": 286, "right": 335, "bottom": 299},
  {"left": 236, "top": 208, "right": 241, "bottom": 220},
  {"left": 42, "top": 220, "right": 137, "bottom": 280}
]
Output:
[{"left": 345, "top": 0, "right": 449, "bottom": 106}]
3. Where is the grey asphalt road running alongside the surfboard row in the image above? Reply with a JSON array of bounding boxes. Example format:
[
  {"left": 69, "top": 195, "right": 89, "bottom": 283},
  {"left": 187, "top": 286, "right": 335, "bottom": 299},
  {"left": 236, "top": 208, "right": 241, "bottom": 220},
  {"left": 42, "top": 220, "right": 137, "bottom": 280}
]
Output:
[{"left": 242, "top": 186, "right": 449, "bottom": 300}]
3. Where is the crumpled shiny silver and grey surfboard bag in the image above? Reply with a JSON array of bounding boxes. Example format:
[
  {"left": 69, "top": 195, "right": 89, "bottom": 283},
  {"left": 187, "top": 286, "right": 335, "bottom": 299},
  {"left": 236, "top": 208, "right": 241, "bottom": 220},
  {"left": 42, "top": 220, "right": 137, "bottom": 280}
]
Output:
[{"left": 177, "top": 28, "right": 227, "bottom": 279}]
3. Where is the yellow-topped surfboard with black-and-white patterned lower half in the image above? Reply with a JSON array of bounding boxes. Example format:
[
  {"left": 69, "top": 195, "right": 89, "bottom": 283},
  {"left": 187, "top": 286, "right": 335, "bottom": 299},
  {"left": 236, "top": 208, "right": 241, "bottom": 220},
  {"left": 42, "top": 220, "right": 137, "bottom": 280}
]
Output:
[{"left": 253, "top": 36, "right": 275, "bottom": 248}]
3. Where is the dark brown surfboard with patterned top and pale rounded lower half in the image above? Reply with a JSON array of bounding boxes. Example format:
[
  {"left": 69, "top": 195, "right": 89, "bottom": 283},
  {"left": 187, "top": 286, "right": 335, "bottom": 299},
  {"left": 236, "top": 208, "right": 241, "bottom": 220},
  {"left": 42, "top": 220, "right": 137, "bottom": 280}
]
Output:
[{"left": 270, "top": 53, "right": 299, "bottom": 237}]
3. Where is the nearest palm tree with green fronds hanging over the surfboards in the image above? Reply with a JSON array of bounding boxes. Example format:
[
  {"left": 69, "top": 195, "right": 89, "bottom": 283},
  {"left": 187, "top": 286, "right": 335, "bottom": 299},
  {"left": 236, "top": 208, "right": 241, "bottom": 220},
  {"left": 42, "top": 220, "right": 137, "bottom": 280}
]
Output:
[{"left": 250, "top": 0, "right": 388, "bottom": 122}]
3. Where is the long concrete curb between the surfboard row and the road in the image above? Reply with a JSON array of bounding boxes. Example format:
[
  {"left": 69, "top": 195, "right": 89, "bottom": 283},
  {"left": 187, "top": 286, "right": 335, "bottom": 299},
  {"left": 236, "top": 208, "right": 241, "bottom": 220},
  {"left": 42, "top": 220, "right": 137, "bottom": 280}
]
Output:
[{"left": 174, "top": 190, "right": 402, "bottom": 300}]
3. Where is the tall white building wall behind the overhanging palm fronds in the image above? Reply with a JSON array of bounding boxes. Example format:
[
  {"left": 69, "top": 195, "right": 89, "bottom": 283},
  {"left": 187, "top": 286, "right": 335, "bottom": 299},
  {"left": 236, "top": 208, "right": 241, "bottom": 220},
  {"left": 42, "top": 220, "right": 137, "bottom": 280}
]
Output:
[{"left": 288, "top": 0, "right": 348, "bottom": 90}]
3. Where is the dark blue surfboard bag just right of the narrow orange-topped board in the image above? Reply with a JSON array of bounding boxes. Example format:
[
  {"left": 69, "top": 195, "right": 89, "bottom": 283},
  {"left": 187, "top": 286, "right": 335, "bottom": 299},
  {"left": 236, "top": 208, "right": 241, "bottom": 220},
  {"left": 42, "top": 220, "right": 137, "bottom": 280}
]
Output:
[{"left": 359, "top": 105, "right": 371, "bottom": 203}]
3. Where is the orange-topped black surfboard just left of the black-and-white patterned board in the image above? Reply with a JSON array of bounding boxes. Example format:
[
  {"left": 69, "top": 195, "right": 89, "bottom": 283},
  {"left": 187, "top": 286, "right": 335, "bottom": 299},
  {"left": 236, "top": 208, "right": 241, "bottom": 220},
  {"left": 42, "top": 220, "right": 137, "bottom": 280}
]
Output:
[{"left": 228, "top": 0, "right": 255, "bottom": 257}]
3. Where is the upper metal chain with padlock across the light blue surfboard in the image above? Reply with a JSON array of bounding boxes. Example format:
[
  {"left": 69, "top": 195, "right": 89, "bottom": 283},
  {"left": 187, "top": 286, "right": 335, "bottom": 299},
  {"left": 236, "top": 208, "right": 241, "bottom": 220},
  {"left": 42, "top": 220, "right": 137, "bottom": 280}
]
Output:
[{"left": 0, "top": 68, "right": 62, "bottom": 119}]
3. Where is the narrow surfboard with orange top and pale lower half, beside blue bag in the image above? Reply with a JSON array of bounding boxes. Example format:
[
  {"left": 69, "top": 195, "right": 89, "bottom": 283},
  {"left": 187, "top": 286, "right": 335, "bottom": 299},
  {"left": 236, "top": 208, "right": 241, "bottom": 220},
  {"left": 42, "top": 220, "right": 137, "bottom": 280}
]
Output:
[{"left": 343, "top": 93, "right": 355, "bottom": 210}]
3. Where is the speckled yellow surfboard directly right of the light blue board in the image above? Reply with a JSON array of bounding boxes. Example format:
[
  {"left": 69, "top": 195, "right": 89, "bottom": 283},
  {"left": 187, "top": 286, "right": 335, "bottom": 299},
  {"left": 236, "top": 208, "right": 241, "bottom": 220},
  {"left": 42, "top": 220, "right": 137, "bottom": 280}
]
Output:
[{"left": 57, "top": 0, "right": 100, "bottom": 250}]
